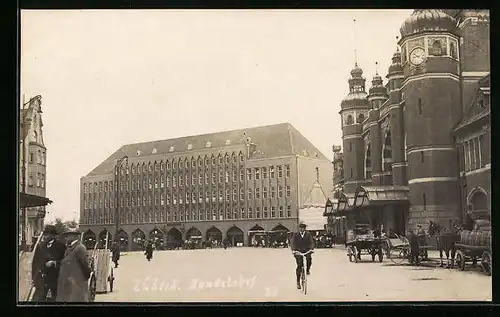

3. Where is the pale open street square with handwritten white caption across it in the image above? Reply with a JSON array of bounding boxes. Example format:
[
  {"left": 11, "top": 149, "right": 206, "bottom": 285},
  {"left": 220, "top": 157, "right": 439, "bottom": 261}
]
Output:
[{"left": 96, "top": 248, "right": 492, "bottom": 302}]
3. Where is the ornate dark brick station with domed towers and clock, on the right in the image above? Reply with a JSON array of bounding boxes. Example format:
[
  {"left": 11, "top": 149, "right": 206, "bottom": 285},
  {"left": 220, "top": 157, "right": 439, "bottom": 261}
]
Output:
[{"left": 326, "top": 9, "right": 491, "bottom": 233}]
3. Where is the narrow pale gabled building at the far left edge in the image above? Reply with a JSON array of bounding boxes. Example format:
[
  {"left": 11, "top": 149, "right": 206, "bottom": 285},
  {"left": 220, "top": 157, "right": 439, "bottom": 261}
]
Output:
[{"left": 19, "top": 96, "right": 47, "bottom": 245}]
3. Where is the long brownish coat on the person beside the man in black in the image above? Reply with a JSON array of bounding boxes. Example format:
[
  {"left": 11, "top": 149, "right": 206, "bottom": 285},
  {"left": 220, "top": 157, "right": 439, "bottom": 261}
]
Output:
[{"left": 56, "top": 241, "right": 90, "bottom": 302}]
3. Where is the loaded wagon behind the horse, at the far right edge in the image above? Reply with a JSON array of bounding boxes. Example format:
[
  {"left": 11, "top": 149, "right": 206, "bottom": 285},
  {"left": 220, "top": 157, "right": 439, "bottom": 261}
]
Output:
[{"left": 455, "top": 230, "right": 492, "bottom": 275}]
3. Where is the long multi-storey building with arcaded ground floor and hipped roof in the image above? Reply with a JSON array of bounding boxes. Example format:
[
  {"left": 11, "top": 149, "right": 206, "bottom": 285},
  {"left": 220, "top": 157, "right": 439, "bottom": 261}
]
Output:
[{"left": 80, "top": 123, "right": 332, "bottom": 249}]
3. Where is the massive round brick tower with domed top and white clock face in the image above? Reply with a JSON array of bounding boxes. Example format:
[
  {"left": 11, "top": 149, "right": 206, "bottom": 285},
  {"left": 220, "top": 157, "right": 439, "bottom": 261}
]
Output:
[{"left": 400, "top": 9, "right": 461, "bottom": 229}]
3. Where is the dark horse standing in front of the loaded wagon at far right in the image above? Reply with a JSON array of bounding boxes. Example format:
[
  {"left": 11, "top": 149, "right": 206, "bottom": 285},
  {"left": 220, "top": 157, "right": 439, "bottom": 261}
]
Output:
[{"left": 428, "top": 221, "right": 460, "bottom": 268}]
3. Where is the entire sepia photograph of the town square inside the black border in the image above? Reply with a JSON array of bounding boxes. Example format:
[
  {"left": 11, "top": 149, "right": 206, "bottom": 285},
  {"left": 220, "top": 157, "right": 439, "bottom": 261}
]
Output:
[{"left": 17, "top": 9, "right": 493, "bottom": 305}]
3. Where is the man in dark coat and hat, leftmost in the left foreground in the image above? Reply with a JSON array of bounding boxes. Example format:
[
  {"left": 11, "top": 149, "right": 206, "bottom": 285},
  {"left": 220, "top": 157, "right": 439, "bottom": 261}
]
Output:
[{"left": 31, "top": 225, "right": 66, "bottom": 302}]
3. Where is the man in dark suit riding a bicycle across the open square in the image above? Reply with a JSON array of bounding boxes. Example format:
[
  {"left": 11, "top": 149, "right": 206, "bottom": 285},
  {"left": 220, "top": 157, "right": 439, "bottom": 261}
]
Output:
[{"left": 290, "top": 221, "right": 314, "bottom": 289}]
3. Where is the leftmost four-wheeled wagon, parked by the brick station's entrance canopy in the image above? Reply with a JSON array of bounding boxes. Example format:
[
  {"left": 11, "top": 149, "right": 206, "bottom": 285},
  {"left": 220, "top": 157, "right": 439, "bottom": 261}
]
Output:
[{"left": 345, "top": 228, "right": 384, "bottom": 263}]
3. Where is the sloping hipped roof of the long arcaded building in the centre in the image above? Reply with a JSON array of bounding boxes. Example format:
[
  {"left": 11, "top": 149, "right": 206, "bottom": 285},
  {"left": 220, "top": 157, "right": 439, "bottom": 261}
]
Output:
[{"left": 87, "top": 123, "right": 328, "bottom": 176}]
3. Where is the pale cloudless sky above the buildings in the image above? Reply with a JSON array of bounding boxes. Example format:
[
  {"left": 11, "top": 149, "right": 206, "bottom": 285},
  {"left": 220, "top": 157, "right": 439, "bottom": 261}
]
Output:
[{"left": 21, "top": 10, "right": 411, "bottom": 222}]
